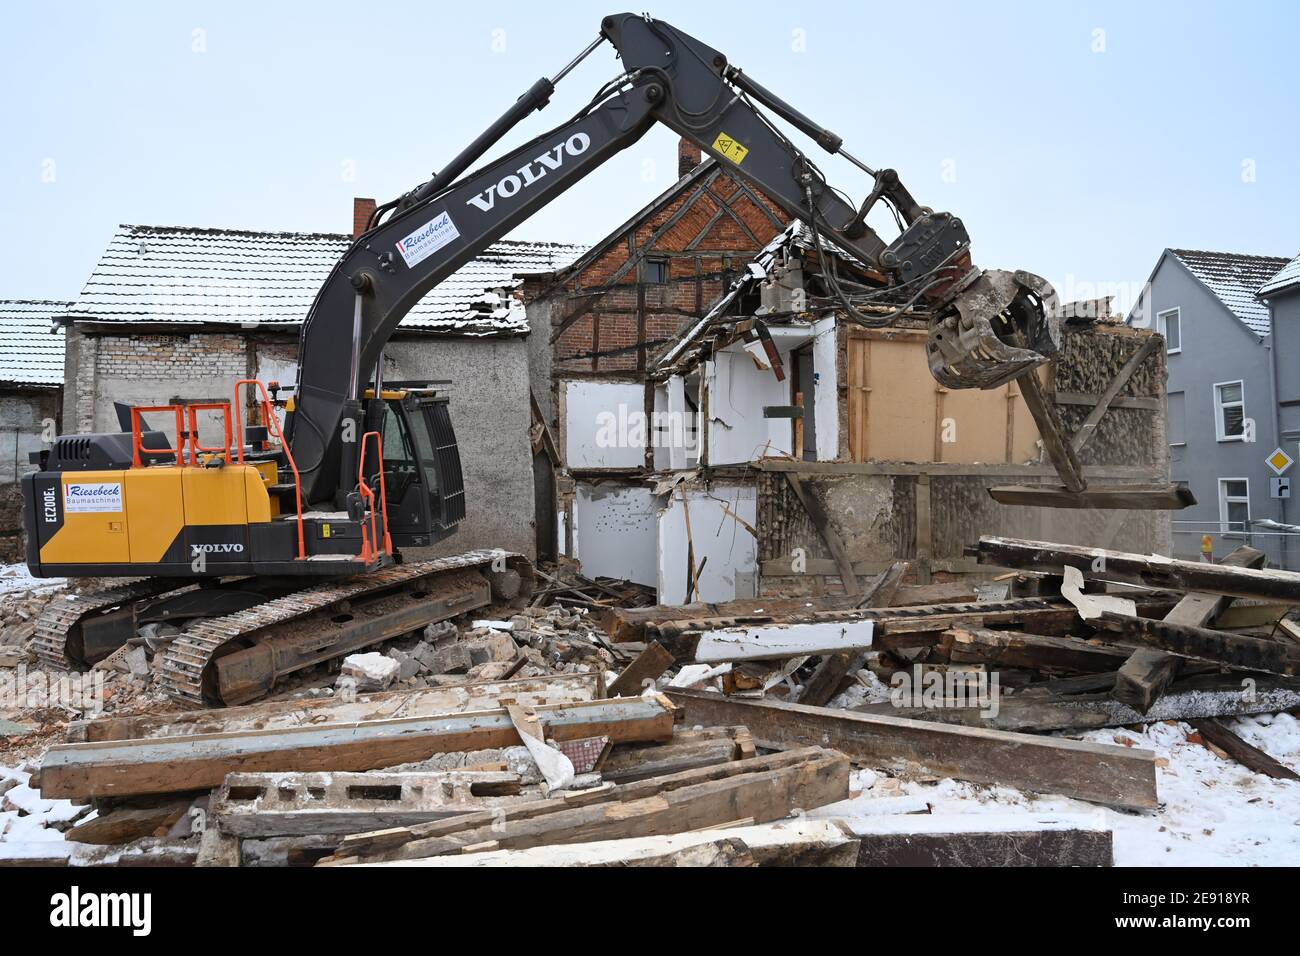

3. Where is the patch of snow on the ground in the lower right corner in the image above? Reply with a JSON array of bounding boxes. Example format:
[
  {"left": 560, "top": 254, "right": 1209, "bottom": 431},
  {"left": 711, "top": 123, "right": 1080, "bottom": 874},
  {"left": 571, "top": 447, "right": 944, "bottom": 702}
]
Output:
[{"left": 813, "top": 714, "right": 1300, "bottom": 866}]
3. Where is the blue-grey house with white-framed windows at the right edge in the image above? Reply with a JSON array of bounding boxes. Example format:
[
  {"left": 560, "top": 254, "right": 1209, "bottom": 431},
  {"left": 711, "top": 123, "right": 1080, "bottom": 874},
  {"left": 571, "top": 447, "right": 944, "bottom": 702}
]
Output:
[{"left": 1128, "top": 248, "right": 1300, "bottom": 567}]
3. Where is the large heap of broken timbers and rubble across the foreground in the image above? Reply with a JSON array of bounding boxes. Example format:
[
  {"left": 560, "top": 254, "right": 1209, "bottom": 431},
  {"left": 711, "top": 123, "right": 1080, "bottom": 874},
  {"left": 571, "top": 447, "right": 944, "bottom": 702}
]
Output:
[{"left": 0, "top": 537, "right": 1300, "bottom": 866}]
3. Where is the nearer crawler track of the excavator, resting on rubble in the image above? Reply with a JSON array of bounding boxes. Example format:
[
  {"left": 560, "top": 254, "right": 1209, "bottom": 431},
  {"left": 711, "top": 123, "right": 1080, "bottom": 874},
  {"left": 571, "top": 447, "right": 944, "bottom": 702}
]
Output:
[{"left": 161, "top": 550, "right": 533, "bottom": 706}]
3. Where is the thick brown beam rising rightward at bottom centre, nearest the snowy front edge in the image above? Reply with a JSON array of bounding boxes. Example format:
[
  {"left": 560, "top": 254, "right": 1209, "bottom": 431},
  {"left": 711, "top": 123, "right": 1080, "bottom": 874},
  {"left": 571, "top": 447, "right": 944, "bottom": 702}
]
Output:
[{"left": 325, "top": 748, "right": 849, "bottom": 862}]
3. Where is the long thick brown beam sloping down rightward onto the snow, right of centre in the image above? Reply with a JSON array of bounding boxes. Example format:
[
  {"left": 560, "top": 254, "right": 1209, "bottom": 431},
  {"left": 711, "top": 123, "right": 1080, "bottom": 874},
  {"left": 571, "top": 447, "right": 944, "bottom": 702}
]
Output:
[{"left": 668, "top": 691, "right": 1157, "bottom": 809}]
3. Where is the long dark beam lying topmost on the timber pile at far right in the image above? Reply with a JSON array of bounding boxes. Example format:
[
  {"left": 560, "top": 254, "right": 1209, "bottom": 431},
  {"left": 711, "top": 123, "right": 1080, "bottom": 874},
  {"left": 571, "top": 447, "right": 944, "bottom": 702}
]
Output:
[{"left": 976, "top": 537, "right": 1300, "bottom": 604}]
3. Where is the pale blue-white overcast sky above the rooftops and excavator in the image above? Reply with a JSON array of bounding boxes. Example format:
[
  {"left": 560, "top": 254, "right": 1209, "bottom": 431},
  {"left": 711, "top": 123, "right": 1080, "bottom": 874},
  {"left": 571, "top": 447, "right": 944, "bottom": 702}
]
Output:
[{"left": 0, "top": 0, "right": 1300, "bottom": 314}]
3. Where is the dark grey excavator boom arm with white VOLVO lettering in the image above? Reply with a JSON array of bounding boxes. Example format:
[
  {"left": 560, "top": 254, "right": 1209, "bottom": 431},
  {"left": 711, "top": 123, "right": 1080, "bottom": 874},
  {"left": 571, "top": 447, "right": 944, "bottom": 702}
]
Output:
[{"left": 289, "top": 13, "right": 1024, "bottom": 502}]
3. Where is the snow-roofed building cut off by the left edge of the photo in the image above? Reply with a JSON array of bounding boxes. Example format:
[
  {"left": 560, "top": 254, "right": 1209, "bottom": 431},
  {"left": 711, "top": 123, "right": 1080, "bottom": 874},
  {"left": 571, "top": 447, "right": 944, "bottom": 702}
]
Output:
[{"left": 0, "top": 299, "right": 72, "bottom": 562}]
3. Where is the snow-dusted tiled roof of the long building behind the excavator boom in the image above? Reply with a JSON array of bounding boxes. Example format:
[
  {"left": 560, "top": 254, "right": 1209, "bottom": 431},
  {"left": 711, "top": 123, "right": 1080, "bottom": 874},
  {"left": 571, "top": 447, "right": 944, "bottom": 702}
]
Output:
[{"left": 69, "top": 225, "right": 584, "bottom": 336}]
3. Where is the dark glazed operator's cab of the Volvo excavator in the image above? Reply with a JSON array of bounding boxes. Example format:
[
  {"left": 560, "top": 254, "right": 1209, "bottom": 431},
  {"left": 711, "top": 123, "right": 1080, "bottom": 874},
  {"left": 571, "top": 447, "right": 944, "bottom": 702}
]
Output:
[{"left": 367, "top": 386, "right": 465, "bottom": 548}]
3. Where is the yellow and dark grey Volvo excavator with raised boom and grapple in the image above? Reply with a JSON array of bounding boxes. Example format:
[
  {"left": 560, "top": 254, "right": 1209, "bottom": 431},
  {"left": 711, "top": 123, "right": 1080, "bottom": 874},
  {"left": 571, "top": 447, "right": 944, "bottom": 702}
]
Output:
[{"left": 22, "top": 13, "right": 1190, "bottom": 705}]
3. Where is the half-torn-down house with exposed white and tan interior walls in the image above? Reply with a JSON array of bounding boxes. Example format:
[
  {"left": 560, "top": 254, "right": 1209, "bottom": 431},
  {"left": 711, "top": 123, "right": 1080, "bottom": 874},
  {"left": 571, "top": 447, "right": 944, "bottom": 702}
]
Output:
[{"left": 560, "top": 226, "right": 1169, "bottom": 604}]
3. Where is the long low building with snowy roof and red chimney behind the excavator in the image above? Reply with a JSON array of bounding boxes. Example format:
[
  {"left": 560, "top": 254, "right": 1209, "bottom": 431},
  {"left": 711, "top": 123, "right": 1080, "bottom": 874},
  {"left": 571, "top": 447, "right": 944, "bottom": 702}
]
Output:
[{"left": 62, "top": 208, "right": 582, "bottom": 558}]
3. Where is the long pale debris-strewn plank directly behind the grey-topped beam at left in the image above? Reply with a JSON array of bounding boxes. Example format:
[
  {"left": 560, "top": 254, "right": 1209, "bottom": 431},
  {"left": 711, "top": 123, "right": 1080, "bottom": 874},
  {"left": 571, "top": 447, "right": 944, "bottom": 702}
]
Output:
[{"left": 68, "top": 672, "right": 605, "bottom": 743}]
